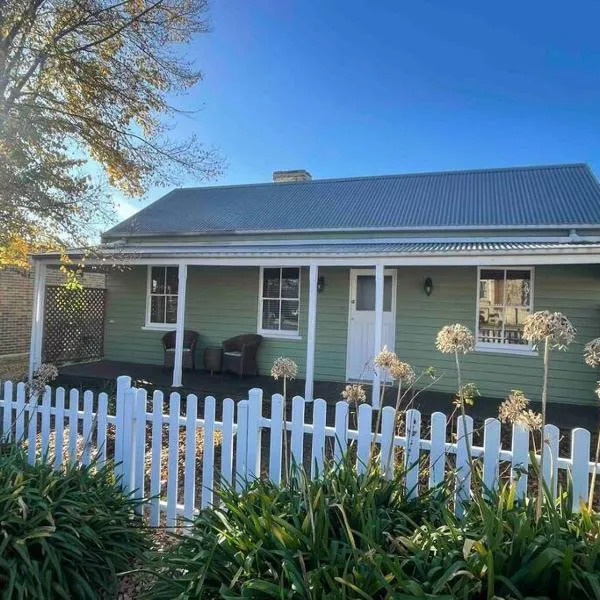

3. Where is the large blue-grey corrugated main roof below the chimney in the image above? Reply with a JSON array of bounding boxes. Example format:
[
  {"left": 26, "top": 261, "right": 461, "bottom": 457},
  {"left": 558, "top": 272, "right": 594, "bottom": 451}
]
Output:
[{"left": 106, "top": 164, "right": 600, "bottom": 237}]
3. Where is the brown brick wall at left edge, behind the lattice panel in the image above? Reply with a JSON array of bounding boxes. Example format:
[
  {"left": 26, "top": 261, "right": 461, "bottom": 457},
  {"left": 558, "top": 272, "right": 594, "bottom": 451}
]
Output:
[{"left": 0, "top": 268, "right": 106, "bottom": 357}]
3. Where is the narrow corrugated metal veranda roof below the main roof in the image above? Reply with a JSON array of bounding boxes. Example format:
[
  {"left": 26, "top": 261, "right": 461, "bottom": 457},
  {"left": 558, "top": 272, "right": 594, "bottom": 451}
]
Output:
[{"left": 88, "top": 241, "right": 600, "bottom": 260}]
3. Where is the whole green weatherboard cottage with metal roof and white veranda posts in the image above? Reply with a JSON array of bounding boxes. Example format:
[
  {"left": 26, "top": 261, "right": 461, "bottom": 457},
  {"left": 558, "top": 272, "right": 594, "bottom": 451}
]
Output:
[{"left": 31, "top": 164, "right": 600, "bottom": 404}]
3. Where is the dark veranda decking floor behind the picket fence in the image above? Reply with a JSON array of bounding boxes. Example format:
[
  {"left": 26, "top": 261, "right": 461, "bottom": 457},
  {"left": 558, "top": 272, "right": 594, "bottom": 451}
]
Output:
[{"left": 57, "top": 360, "right": 598, "bottom": 431}]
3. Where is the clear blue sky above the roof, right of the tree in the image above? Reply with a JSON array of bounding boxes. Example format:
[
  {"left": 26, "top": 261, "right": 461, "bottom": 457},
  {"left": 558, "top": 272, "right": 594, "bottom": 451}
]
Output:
[{"left": 112, "top": 0, "right": 600, "bottom": 216}]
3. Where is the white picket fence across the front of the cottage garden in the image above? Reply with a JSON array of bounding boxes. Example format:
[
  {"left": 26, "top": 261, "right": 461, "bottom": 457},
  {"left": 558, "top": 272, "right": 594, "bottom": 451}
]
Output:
[{"left": 0, "top": 376, "right": 600, "bottom": 527}]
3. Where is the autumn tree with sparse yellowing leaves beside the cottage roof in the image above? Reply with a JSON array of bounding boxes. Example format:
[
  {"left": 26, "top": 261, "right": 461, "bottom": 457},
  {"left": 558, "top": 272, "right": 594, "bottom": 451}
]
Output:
[{"left": 0, "top": 0, "right": 222, "bottom": 266}]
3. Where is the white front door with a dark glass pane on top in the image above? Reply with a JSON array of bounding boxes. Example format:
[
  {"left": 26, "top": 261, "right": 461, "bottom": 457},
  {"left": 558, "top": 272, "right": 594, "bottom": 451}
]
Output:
[{"left": 346, "top": 269, "right": 396, "bottom": 381}]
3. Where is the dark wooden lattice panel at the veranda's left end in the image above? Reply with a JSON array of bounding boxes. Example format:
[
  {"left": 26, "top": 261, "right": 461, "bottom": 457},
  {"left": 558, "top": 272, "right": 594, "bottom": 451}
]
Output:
[{"left": 42, "top": 286, "right": 106, "bottom": 363}]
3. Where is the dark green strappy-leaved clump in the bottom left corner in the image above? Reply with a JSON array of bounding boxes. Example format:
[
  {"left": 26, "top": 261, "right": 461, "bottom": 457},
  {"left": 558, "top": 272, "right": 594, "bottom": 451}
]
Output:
[{"left": 0, "top": 445, "right": 149, "bottom": 600}]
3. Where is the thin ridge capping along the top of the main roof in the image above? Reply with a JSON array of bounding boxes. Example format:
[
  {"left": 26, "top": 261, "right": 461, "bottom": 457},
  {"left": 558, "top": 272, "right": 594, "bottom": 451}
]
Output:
[{"left": 171, "top": 162, "right": 591, "bottom": 192}]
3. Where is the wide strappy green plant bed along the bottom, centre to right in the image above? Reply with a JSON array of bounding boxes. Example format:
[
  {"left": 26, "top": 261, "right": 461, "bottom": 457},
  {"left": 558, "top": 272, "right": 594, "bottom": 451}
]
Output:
[{"left": 150, "top": 459, "right": 600, "bottom": 600}]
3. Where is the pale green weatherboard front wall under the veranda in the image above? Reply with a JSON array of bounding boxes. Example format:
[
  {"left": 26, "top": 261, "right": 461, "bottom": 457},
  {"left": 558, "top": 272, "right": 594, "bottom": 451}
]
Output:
[{"left": 105, "top": 266, "right": 600, "bottom": 403}]
